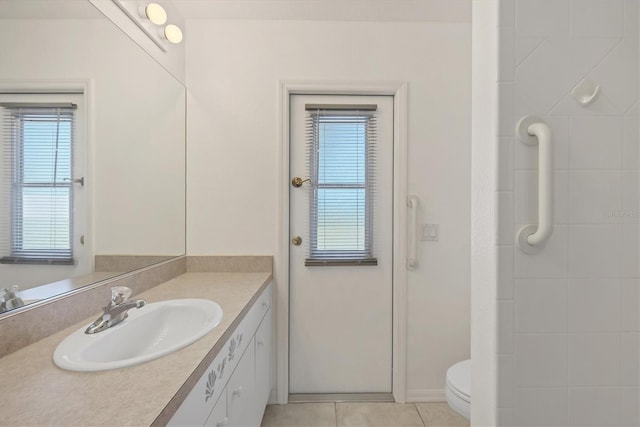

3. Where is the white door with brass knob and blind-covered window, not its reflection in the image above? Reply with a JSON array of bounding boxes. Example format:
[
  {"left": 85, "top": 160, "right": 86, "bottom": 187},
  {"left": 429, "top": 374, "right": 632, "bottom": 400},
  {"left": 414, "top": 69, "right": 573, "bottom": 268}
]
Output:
[{"left": 289, "top": 95, "right": 393, "bottom": 394}]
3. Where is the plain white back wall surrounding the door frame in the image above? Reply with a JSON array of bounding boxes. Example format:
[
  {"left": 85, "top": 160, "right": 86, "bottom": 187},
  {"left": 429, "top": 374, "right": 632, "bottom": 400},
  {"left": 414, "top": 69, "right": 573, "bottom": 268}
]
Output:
[{"left": 186, "top": 19, "right": 471, "bottom": 400}]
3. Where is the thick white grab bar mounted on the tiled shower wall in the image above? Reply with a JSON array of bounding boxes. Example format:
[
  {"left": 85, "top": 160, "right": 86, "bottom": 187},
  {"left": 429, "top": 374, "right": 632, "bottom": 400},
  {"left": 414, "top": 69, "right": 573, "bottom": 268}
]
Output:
[{"left": 516, "top": 116, "right": 553, "bottom": 254}]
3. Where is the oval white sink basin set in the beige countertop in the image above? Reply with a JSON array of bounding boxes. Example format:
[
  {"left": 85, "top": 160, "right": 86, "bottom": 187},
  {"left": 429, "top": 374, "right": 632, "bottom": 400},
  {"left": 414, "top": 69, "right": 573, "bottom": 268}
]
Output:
[{"left": 53, "top": 299, "right": 222, "bottom": 371}]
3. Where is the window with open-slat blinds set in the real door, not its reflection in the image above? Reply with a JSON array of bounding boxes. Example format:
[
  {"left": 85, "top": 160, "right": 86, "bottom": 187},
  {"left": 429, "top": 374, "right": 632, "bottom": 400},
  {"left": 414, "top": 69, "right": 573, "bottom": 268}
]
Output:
[{"left": 305, "top": 105, "right": 377, "bottom": 266}]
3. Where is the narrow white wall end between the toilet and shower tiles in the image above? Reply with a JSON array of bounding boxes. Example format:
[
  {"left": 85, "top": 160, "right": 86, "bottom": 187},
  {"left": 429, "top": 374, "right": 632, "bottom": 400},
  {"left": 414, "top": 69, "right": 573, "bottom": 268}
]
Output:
[{"left": 471, "top": 0, "right": 499, "bottom": 426}]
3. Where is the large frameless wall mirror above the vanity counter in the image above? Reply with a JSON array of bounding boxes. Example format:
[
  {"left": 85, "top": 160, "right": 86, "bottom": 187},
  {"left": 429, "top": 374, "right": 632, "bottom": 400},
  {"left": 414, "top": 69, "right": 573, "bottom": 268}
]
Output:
[{"left": 0, "top": 0, "right": 186, "bottom": 316}]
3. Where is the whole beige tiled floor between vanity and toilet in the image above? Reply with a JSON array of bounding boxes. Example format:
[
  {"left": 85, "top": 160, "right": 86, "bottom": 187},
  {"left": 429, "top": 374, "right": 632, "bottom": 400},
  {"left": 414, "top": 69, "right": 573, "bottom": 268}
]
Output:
[{"left": 262, "top": 403, "right": 469, "bottom": 427}]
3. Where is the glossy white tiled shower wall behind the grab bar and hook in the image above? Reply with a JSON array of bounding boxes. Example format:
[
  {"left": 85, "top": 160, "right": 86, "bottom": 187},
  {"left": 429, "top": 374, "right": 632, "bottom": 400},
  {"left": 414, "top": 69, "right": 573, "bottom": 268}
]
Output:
[{"left": 496, "top": 0, "right": 640, "bottom": 426}]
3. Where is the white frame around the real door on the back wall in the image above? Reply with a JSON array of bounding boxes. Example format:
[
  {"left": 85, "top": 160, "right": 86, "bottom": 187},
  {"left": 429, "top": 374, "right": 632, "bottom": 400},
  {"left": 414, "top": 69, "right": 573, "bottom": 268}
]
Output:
[{"left": 274, "top": 80, "right": 408, "bottom": 404}]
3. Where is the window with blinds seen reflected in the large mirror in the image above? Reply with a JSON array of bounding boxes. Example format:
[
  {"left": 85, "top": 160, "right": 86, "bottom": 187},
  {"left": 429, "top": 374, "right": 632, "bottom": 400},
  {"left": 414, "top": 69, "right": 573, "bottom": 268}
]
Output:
[{"left": 0, "top": 103, "right": 75, "bottom": 264}]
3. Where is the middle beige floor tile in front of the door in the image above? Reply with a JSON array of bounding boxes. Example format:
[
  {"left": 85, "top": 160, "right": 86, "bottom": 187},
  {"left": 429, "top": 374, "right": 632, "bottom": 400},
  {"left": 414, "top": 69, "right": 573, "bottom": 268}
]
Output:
[{"left": 336, "top": 403, "right": 424, "bottom": 427}]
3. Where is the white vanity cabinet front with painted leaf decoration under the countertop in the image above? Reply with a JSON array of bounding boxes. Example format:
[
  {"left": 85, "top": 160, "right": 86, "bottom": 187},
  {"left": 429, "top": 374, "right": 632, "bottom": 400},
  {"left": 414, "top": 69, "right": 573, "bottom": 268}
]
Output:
[{"left": 168, "top": 284, "right": 273, "bottom": 427}]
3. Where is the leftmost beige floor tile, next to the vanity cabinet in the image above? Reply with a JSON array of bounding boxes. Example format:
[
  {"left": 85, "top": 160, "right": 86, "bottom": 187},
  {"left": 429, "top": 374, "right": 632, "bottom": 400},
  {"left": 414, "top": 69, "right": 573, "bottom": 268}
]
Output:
[{"left": 261, "top": 403, "right": 336, "bottom": 427}]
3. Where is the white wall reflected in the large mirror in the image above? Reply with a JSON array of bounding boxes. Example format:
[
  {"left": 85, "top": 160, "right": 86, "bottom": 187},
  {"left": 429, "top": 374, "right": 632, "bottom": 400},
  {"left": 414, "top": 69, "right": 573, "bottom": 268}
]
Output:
[{"left": 0, "top": 18, "right": 185, "bottom": 289}]
